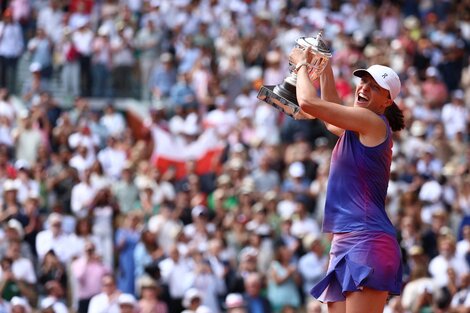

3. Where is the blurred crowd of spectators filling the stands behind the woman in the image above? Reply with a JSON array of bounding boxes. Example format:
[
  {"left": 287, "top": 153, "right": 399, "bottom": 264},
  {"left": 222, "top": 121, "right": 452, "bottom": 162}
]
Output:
[{"left": 0, "top": 0, "right": 470, "bottom": 313}]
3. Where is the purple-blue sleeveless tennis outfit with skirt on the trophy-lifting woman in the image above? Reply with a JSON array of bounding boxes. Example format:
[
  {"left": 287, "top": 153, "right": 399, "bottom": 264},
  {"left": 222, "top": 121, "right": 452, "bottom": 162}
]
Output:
[{"left": 311, "top": 116, "right": 402, "bottom": 302}]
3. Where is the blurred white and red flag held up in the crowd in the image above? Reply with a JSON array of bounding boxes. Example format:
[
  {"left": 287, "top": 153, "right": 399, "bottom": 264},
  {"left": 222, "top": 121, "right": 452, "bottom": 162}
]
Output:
[{"left": 152, "top": 126, "right": 224, "bottom": 179}]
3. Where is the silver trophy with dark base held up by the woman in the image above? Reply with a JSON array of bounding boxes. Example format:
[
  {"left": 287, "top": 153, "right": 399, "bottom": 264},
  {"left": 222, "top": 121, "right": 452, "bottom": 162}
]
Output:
[{"left": 258, "top": 32, "right": 331, "bottom": 119}]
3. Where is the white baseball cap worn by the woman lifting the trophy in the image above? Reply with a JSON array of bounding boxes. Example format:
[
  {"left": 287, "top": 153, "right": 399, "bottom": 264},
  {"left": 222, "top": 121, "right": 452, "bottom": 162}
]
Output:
[{"left": 353, "top": 64, "right": 401, "bottom": 101}]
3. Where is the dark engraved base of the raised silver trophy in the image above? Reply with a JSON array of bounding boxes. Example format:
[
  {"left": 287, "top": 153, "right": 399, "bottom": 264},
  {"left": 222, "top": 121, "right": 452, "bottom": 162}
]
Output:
[{"left": 258, "top": 81, "right": 314, "bottom": 120}]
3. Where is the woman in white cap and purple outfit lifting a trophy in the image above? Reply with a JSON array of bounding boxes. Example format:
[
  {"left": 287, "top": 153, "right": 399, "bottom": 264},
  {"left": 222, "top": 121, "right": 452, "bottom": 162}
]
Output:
[{"left": 289, "top": 42, "right": 404, "bottom": 313}]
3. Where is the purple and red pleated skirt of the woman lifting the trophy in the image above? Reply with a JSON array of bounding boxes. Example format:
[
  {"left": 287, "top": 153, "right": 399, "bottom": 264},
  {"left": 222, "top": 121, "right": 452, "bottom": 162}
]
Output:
[{"left": 310, "top": 231, "right": 402, "bottom": 302}]
